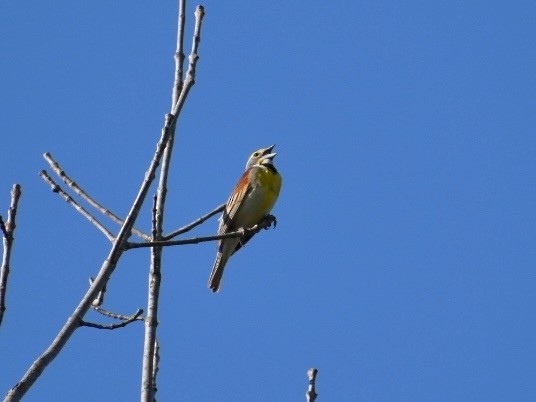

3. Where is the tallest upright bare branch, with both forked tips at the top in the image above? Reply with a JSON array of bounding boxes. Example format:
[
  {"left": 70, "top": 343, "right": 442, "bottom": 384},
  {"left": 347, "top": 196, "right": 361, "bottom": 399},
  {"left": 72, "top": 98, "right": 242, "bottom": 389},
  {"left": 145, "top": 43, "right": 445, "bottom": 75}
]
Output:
[{"left": 141, "top": 0, "right": 204, "bottom": 402}]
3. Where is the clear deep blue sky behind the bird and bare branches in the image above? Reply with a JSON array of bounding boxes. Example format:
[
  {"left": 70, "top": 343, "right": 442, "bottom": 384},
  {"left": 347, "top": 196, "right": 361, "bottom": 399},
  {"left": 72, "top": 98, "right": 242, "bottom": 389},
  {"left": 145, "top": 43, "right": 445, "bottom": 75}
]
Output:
[{"left": 0, "top": 0, "right": 536, "bottom": 401}]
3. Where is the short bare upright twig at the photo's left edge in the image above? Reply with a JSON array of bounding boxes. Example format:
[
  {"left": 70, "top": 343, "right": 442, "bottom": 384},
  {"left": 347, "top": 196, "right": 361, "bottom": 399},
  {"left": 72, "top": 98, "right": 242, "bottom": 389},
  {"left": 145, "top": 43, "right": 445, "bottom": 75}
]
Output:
[{"left": 0, "top": 184, "right": 21, "bottom": 325}]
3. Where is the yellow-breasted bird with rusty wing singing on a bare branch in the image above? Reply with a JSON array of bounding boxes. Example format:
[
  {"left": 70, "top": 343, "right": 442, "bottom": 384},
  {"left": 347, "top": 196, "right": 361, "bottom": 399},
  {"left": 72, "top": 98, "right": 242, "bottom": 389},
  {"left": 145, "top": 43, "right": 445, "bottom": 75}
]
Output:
[{"left": 208, "top": 145, "right": 282, "bottom": 292}]
